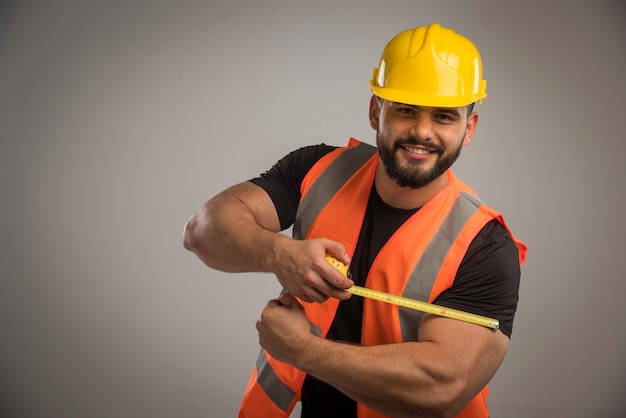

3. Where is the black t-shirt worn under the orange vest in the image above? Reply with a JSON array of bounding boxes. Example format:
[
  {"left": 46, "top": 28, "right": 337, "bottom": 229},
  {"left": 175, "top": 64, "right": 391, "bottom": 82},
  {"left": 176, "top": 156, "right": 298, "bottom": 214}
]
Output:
[{"left": 250, "top": 144, "right": 520, "bottom": 418}]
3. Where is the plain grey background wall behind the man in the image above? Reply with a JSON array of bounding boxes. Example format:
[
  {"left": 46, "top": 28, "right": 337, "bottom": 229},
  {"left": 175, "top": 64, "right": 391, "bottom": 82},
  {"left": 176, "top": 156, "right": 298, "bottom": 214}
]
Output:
[{"left": 0, "top": 0, "right": 626, "bottom": 418}]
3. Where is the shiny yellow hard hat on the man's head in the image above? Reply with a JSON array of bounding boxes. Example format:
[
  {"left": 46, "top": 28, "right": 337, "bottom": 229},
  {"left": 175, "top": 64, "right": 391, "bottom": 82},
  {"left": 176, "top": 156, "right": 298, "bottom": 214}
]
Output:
[{"left": 370, "top": 23, "right": 487, "bottom": 107}]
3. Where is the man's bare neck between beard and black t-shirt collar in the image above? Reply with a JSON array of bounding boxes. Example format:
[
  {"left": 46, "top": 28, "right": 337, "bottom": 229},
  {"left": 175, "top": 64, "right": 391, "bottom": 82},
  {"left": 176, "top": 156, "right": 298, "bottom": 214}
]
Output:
[{"left": 375, "top": 164, "right": 448, "bottom": 209}]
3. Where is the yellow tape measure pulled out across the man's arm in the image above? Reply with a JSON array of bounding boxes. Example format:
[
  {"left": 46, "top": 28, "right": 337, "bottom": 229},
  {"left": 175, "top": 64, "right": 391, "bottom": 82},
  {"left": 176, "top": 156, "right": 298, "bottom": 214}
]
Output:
[{"left": 326, "top": 255, "right": 500, "bottom": 329}]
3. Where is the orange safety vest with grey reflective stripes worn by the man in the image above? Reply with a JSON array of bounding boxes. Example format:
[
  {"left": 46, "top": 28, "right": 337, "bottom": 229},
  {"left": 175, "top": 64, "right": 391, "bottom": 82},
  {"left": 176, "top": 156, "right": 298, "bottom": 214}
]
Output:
[{"left": 239, "top": 138, "right": 527, "bottom": 418}]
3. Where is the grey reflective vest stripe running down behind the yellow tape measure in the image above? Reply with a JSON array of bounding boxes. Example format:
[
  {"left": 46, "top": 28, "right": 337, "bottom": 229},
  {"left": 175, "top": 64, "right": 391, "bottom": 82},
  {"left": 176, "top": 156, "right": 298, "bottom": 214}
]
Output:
[{"left": 399, "top": 192, "right": 482, "bottom": 341}]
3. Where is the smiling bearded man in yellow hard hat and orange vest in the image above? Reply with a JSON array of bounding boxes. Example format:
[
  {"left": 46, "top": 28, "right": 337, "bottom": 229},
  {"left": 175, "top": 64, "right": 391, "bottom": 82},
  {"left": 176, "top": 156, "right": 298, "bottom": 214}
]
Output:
[{"left": 184, "top": 24, "right": 526, "bottom": 418}]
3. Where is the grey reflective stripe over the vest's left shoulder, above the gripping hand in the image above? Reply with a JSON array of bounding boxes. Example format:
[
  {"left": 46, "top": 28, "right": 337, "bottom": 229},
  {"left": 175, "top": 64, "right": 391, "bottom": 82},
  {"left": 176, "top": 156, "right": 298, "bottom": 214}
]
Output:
[{"left": 292, "top": 143, "right": 376, "bottom": 239}]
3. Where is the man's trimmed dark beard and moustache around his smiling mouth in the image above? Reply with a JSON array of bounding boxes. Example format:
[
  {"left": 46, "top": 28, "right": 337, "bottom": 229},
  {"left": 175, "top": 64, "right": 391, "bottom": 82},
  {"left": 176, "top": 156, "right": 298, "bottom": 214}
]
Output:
[{"left": 376, "top": 133, "right": 463, "bottom": 189}]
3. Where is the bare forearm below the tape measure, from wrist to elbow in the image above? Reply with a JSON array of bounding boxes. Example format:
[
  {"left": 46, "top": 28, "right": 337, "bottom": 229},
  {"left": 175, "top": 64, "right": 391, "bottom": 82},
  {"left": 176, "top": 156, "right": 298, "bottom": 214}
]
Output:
[{"left": 297, "top": 338, "right": 460, "bottom": 417}]
